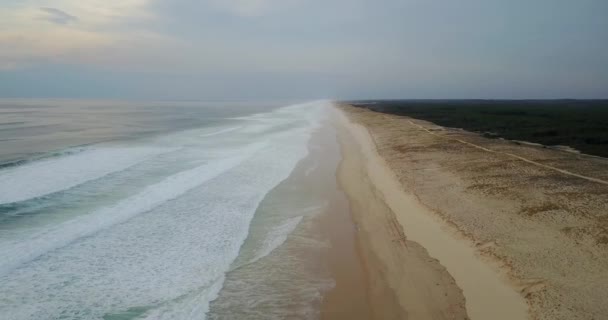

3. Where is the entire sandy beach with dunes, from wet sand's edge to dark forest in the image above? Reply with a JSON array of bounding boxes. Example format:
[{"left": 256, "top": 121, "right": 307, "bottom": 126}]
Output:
[{"left": 336, "top": 105, "right": 608, "bottom": 319}]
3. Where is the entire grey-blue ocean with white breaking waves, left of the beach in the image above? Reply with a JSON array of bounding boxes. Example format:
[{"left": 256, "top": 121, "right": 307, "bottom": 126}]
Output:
[{"left": 0, "top": 100, "right": 339, "bottom": 320}]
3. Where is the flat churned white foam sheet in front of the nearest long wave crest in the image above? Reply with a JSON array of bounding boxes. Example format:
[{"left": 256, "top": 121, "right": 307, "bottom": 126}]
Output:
[{"left": 0, "top": 130, "right": 307, "bottom": 320}]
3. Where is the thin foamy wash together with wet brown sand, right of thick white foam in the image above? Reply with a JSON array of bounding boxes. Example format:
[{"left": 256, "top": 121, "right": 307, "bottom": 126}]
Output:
[{"left": 208, "top": 117, "right": 371, "bottom": 320}]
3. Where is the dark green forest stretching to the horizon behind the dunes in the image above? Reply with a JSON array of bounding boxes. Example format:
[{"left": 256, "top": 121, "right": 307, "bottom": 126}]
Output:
[{"left": 348, "top": 100, "right": 608, "bottom": 157}]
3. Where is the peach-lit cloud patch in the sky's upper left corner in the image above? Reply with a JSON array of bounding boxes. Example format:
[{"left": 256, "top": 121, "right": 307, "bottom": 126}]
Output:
[{"left": 0, "top": 0, "right": 158, "bottom": 71}]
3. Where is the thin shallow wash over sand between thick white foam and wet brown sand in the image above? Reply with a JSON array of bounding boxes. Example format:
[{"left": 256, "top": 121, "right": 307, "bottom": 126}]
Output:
[{"left": 209, "top": 119, "right": 350, "bottom": 319}]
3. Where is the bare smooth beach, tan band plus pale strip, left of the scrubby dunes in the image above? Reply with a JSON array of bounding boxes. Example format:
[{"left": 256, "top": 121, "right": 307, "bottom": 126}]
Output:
[{"left": 335, "top": 104, "right": 528, "bottom": 319}]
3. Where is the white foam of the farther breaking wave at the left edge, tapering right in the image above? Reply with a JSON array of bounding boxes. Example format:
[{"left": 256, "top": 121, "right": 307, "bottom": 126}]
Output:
[{"left": 0, "top": 147, "right": 169, "bottom": 204}]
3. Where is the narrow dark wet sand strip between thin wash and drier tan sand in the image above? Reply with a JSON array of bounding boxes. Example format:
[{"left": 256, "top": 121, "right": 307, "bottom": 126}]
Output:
[{"left": 309, "top": 122, "right": 372, "bottom": 320}]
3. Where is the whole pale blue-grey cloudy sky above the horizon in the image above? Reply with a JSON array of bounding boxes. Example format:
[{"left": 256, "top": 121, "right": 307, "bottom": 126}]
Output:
[{"left": 0, "top": 0, "right": 608, "bottom": 100}]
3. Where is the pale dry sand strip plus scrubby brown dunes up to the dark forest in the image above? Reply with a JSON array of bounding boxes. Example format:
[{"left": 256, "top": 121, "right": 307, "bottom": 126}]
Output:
[{"left": 336, "top": 104, "right": 608, "bottom": 320}]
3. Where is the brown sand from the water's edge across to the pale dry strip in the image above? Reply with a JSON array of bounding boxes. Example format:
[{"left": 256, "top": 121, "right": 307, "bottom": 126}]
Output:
[{"left": 318, "top": 106, "right": 468, "bottom": 320}]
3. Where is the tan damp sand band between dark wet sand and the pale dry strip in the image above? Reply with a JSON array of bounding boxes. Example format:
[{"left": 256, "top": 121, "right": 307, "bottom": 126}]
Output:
[{"left": 336, "top": 109, "right": 468, "bottom": 319}]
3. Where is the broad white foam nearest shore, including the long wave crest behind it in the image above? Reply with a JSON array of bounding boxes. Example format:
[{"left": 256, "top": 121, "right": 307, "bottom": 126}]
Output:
[{"left": 0, "top": 102, "right": 332, "bottom": 320}]
